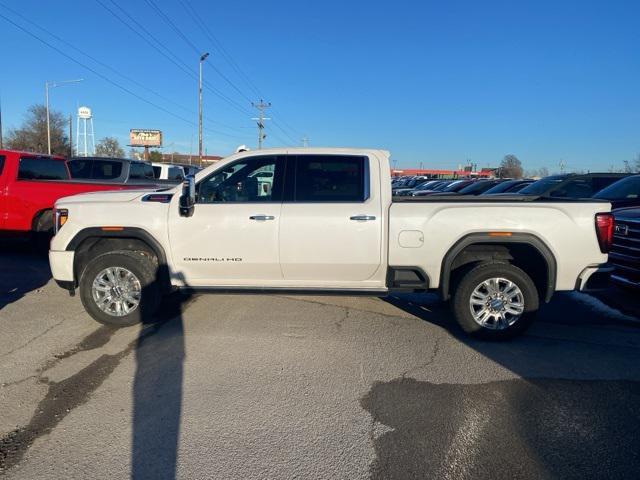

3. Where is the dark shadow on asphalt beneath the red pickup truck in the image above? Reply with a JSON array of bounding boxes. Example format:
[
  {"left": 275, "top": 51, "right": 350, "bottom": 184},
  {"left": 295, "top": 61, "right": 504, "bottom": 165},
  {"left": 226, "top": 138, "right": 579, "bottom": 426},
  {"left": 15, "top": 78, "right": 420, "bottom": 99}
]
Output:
[{"left": 0, "top": 239, "right": 51, "bottom": 310}]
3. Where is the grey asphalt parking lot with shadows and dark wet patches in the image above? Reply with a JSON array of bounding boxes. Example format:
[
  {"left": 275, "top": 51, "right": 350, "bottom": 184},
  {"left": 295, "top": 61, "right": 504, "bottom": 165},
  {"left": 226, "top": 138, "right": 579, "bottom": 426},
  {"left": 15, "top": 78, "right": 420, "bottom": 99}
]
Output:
[{"left": 0, "top": 245, "right": 640, "bottom": 479}]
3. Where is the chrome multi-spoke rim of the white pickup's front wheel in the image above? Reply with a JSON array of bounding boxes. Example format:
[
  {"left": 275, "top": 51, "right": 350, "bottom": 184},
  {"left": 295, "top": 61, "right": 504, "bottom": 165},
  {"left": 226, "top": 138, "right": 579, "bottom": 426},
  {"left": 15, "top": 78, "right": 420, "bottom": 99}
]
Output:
[{"left": 91, "top": 267, "right": 142, "bottom": 317}]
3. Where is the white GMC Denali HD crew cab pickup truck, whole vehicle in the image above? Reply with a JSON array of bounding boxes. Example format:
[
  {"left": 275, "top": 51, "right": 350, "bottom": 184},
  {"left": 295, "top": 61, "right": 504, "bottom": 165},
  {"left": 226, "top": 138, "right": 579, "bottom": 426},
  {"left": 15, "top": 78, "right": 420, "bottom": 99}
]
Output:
[{"left": 49, "top": 148, "right": 613, "bottom": 338}]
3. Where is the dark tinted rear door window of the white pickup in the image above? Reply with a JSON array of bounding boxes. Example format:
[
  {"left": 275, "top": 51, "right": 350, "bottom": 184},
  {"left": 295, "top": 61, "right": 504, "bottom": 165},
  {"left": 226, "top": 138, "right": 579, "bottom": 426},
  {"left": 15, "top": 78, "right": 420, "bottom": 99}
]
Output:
[{"left": 294, "top": 155, "right": 367, "bottom": 202}]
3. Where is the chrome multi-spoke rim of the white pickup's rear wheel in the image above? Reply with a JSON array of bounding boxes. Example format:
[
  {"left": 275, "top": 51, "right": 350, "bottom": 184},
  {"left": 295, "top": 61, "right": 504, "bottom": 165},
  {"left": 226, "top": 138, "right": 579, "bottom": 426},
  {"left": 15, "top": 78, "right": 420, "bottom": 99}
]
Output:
[{"left": 469, "top": 278, "right": 524, "bottom": 330}]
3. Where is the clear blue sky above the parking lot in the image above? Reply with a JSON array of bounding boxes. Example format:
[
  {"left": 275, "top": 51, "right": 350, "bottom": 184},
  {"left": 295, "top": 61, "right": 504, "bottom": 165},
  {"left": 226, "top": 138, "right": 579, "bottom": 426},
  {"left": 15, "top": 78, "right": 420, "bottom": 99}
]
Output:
[{"left": 0, "top": 0, "right": 640, "bottom": 171}]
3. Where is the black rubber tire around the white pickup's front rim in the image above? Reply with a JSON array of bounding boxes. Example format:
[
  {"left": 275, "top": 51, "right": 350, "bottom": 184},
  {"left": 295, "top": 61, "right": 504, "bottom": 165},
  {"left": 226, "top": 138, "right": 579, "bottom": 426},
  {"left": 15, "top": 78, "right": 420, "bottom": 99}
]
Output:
[{"left": 79, "top": 250, "right": 160, "bottom": 327}]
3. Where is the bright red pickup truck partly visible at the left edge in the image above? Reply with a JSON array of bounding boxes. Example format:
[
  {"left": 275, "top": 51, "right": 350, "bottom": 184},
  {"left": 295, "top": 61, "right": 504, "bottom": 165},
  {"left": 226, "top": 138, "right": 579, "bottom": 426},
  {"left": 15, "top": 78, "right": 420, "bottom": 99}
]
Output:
[{"left": 0, "top": 150, "right": 138, "bottom": 236}]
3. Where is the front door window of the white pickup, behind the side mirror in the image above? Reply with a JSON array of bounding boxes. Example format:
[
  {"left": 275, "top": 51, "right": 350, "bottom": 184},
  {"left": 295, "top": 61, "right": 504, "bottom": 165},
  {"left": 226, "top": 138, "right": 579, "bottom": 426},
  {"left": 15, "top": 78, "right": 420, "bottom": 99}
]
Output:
[{"left": 198, "top": 157, "right": 282, "bottom": 203}]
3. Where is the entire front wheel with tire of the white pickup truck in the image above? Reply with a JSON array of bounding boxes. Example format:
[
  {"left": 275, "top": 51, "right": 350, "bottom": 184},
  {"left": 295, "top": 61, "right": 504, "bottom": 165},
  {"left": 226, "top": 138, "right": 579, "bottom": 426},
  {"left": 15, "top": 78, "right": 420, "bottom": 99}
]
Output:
[{"left": 79, "top": 250, "right": 160, "bottom": 327}]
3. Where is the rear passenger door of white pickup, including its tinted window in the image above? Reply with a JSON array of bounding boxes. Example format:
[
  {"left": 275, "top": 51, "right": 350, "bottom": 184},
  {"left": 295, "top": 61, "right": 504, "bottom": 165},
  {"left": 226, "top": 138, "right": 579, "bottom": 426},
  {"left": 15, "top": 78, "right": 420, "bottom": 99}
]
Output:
[{"left": 280, "top": 154, "right": 383, "bottom": 287}]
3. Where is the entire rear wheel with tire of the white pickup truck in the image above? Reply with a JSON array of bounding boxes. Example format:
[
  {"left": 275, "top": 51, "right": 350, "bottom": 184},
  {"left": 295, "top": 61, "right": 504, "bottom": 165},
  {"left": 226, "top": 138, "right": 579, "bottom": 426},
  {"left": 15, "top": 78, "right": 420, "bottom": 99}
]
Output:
[{"left": 452, "top": 262, "right": 539, "bottom": 340}]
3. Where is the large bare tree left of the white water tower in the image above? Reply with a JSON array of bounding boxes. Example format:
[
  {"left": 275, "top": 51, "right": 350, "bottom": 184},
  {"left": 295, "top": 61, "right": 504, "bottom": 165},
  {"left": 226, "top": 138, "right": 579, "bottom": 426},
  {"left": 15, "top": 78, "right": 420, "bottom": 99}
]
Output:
[{"left": 6, "top": 105, "right": 69, "bottom": 156}]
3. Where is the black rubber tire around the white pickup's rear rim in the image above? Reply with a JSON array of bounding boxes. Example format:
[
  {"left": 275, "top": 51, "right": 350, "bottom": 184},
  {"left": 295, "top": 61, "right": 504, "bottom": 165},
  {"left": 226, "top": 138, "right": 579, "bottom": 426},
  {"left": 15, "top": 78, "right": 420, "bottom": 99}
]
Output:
[{"left": 451, "top": 262, "right": 539, "bottom": 340}]
